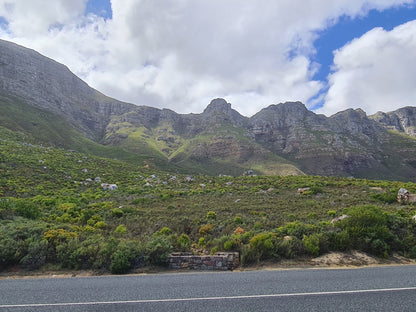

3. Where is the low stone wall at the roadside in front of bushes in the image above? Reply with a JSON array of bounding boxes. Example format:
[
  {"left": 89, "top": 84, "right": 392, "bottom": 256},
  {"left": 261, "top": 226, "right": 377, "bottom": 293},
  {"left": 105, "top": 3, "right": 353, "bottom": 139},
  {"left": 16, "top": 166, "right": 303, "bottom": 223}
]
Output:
[{"left": 169, "top": 252, "right": 240, "bottom": 271}]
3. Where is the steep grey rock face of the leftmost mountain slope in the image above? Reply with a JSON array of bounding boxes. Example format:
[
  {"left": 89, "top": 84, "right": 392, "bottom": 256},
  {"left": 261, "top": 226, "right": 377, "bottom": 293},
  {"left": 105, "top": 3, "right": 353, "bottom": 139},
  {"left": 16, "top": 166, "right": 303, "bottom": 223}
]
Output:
[{"left": 0, "top": 40, "right": 135, "bottom": 139}]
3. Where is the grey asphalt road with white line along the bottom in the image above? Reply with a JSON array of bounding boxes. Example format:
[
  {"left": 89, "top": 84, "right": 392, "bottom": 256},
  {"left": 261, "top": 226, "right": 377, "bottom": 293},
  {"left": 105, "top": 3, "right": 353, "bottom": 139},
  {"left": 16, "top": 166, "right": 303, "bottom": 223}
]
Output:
[{"left": 0, "top": 266, "right": 416, "bottom": 312}]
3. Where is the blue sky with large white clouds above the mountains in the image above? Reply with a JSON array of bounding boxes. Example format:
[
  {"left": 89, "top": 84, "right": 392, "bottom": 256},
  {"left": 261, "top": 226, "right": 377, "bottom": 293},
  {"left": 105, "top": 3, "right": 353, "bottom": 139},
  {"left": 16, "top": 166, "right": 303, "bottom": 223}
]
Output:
[{"left": 0, "top": 0, "right": 416, "bottom": 116}]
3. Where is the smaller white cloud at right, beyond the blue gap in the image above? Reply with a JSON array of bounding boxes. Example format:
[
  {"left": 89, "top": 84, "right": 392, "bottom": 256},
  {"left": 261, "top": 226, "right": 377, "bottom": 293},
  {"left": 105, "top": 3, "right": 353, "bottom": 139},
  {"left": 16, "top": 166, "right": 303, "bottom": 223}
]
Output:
[{"left": 318, "top": 20, "right": 416, "bottom": 115}]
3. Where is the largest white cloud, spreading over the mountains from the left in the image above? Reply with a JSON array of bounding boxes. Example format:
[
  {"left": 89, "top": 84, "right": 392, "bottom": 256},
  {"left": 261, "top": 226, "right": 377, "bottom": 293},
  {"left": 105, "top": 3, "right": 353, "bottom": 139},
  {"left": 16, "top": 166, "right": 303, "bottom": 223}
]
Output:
[{"left": 0, "top": 0, "right": 414, "bottom": 115}]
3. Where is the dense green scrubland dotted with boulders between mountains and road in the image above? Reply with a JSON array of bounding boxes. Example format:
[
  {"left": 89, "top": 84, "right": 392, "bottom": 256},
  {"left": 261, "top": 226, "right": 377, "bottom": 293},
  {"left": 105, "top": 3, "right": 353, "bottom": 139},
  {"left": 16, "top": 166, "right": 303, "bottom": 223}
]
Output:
[{"left": 0, "top": 129, "right": 416, "bottom": 273}]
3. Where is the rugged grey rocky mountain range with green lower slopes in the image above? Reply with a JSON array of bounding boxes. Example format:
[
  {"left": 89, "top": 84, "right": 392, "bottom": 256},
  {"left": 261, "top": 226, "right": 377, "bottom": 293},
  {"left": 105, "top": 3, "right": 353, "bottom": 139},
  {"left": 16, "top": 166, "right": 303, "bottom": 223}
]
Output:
[{"left": 0, "top": 40, "right": 416, "bottom": 180}]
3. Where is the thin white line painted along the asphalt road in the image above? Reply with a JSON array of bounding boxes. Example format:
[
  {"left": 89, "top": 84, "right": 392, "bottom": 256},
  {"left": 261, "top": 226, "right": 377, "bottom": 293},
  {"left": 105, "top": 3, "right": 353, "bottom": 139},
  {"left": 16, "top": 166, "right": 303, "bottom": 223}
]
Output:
[{"left": 0, "top": 287, "right": 416, "bottom": 308}]
